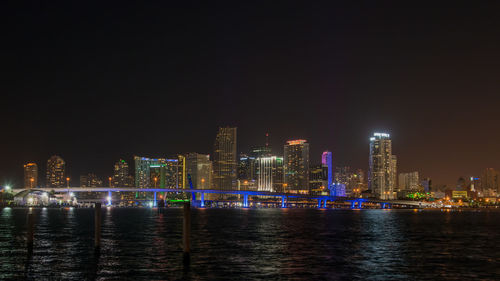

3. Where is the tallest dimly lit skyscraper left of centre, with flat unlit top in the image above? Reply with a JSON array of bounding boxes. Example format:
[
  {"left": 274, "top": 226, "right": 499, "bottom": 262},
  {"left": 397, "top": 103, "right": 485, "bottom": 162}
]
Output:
[{"left": 213, "top": 127, "right": 238, "bottom": 190}]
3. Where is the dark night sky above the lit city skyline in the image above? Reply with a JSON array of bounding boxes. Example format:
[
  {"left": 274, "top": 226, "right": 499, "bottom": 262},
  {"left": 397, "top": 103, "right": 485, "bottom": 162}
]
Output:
[{"left": 0, "top": 1, "right": 500, "bottom": 185}]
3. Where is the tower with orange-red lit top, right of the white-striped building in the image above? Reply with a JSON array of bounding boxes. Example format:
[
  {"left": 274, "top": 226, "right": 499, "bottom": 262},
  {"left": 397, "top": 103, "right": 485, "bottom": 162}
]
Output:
[{"left": 283, "top": 140, "right": 309, "bottom": 194}]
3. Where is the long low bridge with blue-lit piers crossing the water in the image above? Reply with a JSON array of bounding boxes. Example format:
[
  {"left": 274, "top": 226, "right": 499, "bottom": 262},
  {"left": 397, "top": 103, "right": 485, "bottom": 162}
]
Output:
[{"left": 12, "top": 187, "right": 428, "bottom": 209}]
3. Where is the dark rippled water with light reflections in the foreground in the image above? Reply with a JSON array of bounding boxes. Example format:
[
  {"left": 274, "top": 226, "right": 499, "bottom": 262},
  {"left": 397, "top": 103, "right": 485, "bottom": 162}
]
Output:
[{"left": 0, "top": 208, "right": 500, "bottom": 280}]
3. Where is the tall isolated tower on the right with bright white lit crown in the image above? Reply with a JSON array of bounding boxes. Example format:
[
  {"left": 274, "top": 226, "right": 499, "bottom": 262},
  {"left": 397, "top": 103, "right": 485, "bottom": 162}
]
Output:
[{"left": 368, "top": 133, "right": 397, "bottom": 199}]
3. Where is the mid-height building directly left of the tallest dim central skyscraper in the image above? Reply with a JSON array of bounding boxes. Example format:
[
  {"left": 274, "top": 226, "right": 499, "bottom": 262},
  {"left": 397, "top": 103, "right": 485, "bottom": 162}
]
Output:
[{"left": 186, "top": 153, "right": 212, "bottom": 189}]
